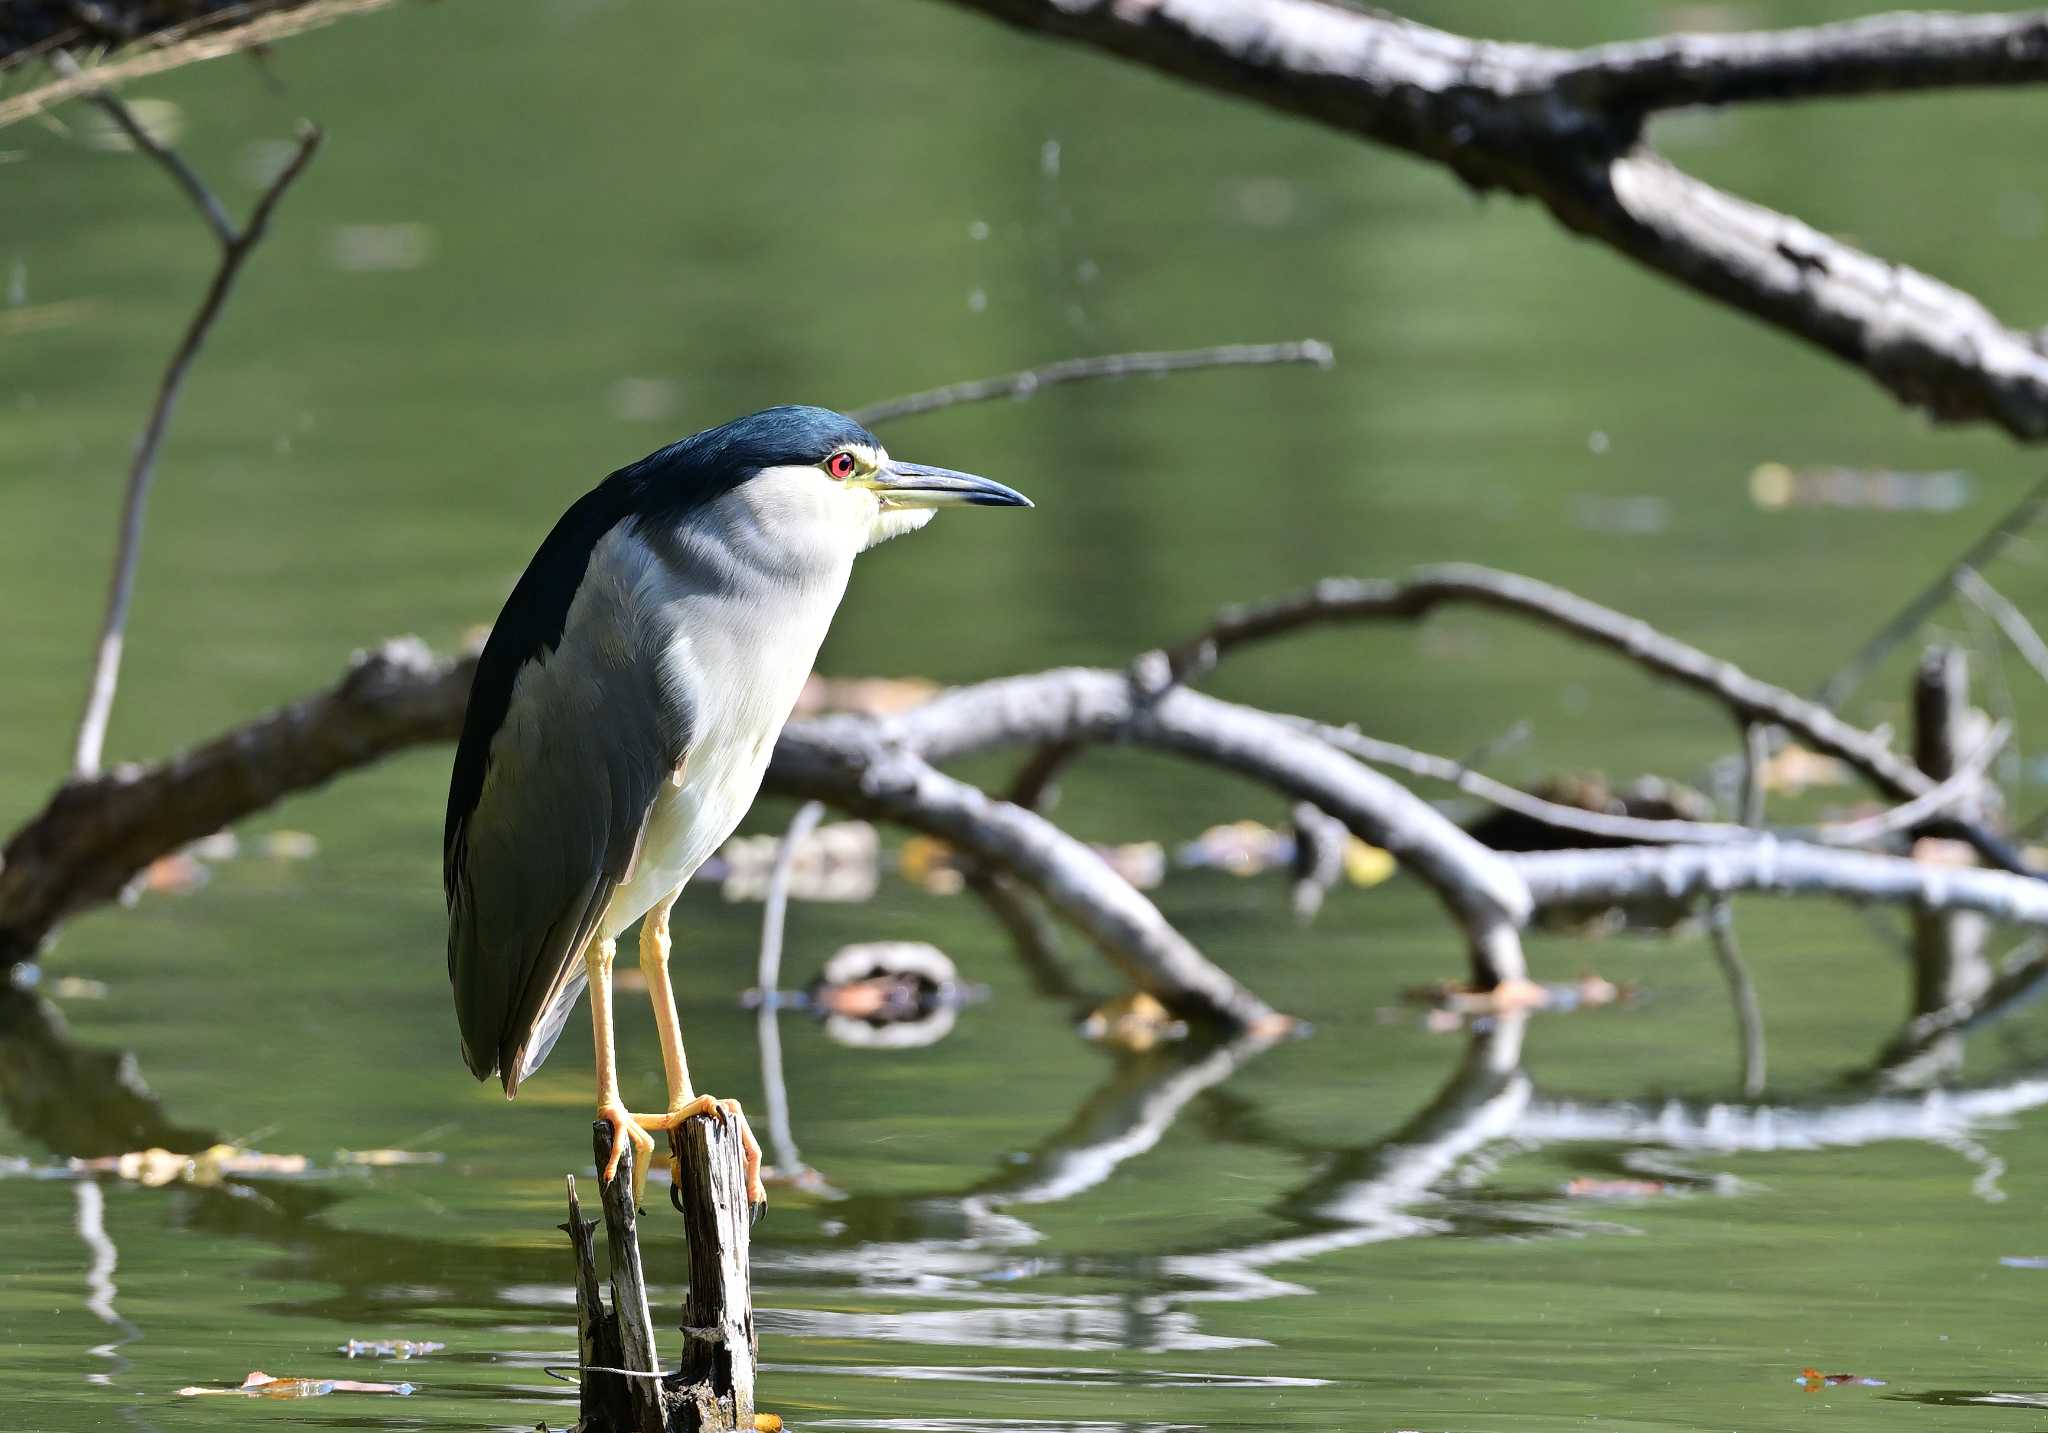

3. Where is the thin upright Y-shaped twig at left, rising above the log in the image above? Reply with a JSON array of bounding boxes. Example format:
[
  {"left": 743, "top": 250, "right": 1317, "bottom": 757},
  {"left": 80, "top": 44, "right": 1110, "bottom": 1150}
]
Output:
[{"left": 72, "top": 117, "right": 322, "bottom": 778}]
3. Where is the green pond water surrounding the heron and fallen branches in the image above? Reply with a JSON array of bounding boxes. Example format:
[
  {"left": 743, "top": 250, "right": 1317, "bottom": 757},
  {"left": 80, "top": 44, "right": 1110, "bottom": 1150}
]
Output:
[{"left": 12, "top": 0, "right": 2048, "bottom": 1433}]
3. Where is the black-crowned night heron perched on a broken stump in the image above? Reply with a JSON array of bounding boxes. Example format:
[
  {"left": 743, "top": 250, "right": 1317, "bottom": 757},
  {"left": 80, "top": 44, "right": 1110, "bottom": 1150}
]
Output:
[{"left": 442, "top": 407, "right": 1030, "bottom": 1206}]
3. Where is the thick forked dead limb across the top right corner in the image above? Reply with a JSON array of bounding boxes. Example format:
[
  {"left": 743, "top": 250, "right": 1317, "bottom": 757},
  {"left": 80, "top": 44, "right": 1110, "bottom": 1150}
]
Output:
[{"left": 937, "top": 0, "right": 2048, "bottom": 440}]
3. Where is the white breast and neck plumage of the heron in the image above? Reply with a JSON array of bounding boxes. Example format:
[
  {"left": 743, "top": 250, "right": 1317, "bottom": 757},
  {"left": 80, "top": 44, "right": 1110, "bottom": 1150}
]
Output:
[{"left": 594, "top": 469, "right": 866, "bottom": 936}]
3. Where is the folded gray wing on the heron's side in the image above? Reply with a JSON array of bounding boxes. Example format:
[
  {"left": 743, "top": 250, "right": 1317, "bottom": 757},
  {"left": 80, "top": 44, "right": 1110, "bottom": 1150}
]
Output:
[{"left": 444, "top": 528, "right": 688, "bottom": 1095}]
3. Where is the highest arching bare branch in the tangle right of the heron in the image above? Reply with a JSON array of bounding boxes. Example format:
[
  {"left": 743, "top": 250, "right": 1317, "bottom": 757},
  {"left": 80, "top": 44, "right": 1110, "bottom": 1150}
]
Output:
[{"left": 1169, "top": 563, "right": 1935, "bottom": 798}]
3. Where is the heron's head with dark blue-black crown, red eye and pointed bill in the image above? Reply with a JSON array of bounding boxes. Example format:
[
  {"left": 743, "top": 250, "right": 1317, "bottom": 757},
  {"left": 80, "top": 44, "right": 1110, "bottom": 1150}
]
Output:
[{"left": 643, "top": 405, "right": 1032, "bottom": 553}]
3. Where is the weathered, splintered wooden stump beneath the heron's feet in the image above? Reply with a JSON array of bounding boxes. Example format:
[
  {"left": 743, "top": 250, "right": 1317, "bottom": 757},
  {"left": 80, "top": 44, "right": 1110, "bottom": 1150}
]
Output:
[{"left": 561, "top": 1116, "right": 766, "bottom": 1433}]
